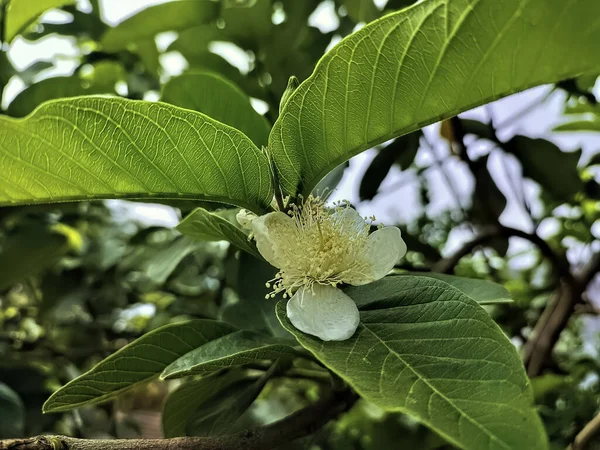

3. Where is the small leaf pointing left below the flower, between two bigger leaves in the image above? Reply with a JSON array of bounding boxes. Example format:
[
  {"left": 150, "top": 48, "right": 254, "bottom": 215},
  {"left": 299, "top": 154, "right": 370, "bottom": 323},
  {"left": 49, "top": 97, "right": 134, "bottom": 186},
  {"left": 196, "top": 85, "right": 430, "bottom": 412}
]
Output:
[{"left": 161, "top": 330, "right": 297, "bottom": 380}]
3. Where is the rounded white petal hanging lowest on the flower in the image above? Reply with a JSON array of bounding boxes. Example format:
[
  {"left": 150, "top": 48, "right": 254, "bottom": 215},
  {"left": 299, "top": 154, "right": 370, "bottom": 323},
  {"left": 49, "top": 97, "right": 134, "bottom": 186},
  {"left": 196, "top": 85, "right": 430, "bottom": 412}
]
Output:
[{"left": 287, "top": 284, "right": 360, "bottom": 341}]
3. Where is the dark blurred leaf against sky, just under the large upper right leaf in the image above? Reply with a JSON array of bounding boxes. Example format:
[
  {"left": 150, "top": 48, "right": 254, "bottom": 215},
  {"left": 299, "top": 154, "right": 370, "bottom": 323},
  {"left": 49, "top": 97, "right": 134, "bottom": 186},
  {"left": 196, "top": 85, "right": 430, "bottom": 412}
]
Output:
[{"left": 358, "top": 130, "right": 422, "bottom": 200}]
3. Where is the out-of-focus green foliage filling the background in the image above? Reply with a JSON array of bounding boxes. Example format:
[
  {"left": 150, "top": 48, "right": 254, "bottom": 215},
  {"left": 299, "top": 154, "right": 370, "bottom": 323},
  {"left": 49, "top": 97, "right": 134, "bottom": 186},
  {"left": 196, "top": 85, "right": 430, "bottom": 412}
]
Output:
[{"left": 0, "top": 0, "right": 600, "bottom": 449}]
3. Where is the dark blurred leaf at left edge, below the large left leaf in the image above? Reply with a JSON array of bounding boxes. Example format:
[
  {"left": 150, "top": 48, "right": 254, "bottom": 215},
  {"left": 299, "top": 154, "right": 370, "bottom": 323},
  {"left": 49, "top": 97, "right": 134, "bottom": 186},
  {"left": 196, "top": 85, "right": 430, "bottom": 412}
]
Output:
[{"left": 0, "top": 225, "right": 70, "bottom": 289}]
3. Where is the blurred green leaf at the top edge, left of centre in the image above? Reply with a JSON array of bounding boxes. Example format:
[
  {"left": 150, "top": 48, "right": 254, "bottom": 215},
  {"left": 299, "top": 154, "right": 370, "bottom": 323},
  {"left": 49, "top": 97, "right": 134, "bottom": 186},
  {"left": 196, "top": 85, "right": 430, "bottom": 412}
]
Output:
[{"left": 100, "top": 0, "right": 220, "bottom": 53}]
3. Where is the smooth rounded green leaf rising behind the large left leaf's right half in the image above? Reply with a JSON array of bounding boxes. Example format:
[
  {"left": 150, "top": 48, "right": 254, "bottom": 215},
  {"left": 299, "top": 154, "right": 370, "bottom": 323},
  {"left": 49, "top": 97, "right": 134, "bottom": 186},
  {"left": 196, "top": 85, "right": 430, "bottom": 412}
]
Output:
[{"left": 162, "top": 72, "right": 271, "bottom": 148}]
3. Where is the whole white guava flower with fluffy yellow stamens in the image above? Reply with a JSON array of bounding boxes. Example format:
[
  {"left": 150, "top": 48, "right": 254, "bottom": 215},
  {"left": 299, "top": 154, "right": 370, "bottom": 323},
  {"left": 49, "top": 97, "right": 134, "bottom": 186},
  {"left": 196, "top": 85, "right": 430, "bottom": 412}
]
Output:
[{"left": 237, "top": 196, "right": 406, "bottom": 341}]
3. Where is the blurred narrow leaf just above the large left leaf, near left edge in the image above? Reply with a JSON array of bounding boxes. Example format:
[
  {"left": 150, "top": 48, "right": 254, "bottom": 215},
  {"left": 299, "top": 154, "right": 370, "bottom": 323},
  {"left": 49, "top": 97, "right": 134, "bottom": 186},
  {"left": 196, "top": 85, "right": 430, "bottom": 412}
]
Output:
[{"left": 6, "top": 61, "right": 125, "bottom": 117}]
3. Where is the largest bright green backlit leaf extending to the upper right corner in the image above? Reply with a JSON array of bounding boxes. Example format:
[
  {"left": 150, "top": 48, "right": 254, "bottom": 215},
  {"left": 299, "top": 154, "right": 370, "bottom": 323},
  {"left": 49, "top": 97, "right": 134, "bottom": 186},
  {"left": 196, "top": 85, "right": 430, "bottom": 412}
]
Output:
[{"left": 269, "top": 0, "right": 600, "bottom": 195}]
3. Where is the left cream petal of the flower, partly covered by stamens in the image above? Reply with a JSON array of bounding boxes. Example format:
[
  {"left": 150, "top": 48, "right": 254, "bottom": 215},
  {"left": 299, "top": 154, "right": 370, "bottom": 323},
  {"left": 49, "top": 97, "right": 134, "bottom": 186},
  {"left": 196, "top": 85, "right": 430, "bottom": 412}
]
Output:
[{"left": 251, "top": 212, "right": 294, "bottom": 268}]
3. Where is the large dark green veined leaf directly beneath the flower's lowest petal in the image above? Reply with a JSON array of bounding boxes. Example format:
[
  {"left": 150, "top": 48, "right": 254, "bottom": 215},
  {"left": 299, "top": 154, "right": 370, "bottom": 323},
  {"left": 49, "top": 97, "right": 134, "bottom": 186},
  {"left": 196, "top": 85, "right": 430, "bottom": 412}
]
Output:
[{"left": 277, "top": 276, "right": 547, "bottom": 450}]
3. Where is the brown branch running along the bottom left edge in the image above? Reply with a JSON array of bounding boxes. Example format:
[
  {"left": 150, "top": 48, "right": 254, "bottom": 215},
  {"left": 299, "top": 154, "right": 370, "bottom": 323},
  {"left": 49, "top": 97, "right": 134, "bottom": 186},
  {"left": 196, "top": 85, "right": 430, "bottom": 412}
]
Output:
[{"left": 0, "top": 390, "right": 357, "bottom": 450}]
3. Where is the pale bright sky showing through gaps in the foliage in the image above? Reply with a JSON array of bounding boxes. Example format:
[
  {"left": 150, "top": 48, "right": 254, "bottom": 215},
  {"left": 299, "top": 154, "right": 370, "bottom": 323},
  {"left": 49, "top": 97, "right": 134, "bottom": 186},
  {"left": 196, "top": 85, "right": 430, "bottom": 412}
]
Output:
[{"left": 3, "top": 0, "right": 600, "bottom": 252}]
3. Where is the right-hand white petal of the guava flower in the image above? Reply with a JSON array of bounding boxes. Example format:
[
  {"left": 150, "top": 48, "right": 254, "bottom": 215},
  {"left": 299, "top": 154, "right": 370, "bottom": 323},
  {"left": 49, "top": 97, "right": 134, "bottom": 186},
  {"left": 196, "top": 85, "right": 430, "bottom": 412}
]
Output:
[{"left": 344, "top": 227, "right": 406, "bottom": 286}]
